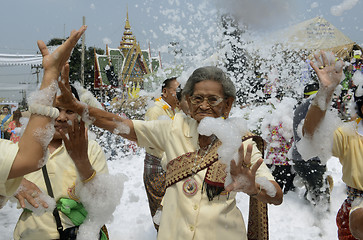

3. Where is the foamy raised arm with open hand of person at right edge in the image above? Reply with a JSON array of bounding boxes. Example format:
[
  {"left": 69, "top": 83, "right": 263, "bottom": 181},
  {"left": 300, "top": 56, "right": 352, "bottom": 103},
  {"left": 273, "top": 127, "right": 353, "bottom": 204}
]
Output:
[{"left": 303, "top": 52, "right": 344, "bottom": 137}]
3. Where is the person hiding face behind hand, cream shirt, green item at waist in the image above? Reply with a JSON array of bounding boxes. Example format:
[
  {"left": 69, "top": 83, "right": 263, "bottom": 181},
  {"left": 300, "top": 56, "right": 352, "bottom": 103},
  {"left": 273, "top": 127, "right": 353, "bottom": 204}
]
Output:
[{"left": 13, "top": 72, "right": 108, "bottom": 240}]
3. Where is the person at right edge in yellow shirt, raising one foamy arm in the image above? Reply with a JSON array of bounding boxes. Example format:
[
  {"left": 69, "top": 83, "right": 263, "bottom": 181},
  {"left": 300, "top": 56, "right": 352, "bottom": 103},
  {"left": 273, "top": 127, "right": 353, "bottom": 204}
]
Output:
[{"left": 302, "top": 52, "right": 363, "bottom": 240}]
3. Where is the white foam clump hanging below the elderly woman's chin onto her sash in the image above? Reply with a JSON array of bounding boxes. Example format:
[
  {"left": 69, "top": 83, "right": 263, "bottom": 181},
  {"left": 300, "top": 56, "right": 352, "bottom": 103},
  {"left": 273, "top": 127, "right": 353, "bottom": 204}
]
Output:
[{"left": 198, "top": 117, "right": 248, "bottom": 186}]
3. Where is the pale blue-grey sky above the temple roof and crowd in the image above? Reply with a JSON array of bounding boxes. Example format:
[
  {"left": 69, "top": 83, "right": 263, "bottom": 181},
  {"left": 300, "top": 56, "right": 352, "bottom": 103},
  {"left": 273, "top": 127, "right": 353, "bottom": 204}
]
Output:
[{"left": 0, "top": 0, "right": 363, "bottom": 102}]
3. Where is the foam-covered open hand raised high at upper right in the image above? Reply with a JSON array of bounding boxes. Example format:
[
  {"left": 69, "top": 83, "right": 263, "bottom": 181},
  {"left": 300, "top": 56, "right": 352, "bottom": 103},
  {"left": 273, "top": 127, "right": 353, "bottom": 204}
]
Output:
[{"left": 310, "top": 51, "right": 344, "bottom": 91}]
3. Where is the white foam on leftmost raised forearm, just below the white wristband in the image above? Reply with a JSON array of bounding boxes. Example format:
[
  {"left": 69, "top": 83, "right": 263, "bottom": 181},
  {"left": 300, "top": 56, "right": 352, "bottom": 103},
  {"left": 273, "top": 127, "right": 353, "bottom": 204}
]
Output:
[{"left": 33, "top": 120, "right": 55, "bottom": 167}]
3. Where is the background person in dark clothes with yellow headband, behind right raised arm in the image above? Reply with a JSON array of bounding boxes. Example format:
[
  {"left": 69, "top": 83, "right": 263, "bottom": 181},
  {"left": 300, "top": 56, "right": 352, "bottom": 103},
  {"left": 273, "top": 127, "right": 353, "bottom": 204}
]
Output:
[{"left": 292, "top": 82, "right": 330, "bottom": 207}]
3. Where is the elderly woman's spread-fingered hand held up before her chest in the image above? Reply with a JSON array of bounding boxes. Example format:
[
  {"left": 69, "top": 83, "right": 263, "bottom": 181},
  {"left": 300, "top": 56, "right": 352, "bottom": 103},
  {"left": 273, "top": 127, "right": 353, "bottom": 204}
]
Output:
[{"left": 225, "top": 144, "right": 263, "bottom": 195}]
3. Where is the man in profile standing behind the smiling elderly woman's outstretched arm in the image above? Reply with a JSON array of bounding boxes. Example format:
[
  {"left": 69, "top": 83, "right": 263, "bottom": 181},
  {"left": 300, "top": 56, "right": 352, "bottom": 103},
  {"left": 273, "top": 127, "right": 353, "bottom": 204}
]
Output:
[{"left": 144, "top": 77, "right": 180, "bottom": 231}]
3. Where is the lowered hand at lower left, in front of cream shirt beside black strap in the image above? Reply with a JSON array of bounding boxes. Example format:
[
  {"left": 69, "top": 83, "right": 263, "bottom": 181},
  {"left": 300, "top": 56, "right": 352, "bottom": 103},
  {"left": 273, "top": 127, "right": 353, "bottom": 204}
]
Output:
[{"left": 15, "top": 178, "right": 48, "bottom": 208}]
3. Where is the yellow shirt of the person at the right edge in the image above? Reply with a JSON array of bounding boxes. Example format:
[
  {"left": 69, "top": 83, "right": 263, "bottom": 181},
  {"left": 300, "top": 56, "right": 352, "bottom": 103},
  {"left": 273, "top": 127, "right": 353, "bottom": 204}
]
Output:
[{"left": 333, "top": 128, "right": 363, "bottom": 190}]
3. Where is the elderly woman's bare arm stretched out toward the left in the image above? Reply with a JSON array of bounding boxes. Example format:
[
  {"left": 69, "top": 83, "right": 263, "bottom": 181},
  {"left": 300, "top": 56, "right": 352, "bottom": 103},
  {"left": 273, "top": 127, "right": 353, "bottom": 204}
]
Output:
[{"left": 57, "top": 79, "right": 137, "bottom": 141}]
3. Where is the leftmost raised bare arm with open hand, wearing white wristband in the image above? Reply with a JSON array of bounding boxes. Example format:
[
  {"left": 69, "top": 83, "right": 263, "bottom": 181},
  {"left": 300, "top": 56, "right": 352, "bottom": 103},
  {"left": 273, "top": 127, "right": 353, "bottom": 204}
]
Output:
[{"left": 8, "top": 26, "right": 87, "bottom": 179}]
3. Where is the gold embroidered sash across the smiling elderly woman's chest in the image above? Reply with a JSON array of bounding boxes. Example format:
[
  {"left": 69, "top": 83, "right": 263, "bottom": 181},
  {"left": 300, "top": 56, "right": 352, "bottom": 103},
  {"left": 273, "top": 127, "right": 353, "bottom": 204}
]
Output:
[{"left": 166, "top": 140, "right": 227, "bottom": 187}]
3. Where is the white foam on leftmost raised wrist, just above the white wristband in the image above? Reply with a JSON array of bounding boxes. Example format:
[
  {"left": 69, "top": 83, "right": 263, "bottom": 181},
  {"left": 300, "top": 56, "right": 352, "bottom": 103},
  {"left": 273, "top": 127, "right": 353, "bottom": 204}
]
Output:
[{"left": 28, "top": 79, "right": 58, "bottom": 106}]
